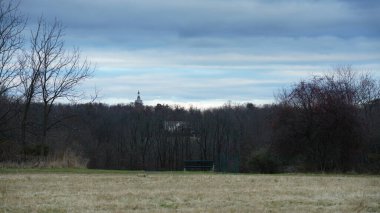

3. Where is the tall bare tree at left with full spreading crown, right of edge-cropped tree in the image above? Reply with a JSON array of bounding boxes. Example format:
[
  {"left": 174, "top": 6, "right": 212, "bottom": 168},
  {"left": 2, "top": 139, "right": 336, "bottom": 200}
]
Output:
[{"left": 28, "top": 18, "right": 91, "bottom": 154}]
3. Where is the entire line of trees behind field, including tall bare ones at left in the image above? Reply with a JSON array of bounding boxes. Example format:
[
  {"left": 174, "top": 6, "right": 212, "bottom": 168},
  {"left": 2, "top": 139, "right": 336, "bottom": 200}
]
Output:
[{"left": 0, "top": 1, "right": 380, "bottom": 173}]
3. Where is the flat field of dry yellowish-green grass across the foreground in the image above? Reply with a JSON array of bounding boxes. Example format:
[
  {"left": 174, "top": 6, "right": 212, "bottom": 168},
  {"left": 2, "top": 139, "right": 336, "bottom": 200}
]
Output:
[{"left": 0, "top": 169, "right": 380, "bottom": 212}]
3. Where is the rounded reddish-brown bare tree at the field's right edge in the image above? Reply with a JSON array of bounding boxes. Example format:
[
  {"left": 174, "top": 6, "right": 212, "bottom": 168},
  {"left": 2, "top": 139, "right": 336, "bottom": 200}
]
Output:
[{"left": 275, "top": 66, "right": 379, "bottom": 171}]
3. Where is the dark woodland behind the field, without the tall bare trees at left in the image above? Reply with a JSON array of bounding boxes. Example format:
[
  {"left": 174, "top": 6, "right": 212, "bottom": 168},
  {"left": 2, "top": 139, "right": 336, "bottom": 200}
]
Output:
[{"left": 0, "top": 68, "right": 380, "bottom": 173}]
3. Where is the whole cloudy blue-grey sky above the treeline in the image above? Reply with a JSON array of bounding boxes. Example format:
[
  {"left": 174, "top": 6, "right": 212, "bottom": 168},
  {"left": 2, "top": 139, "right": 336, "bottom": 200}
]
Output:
[{"left": 20, "top": 0, "right": 380, "bottom": 108}]
